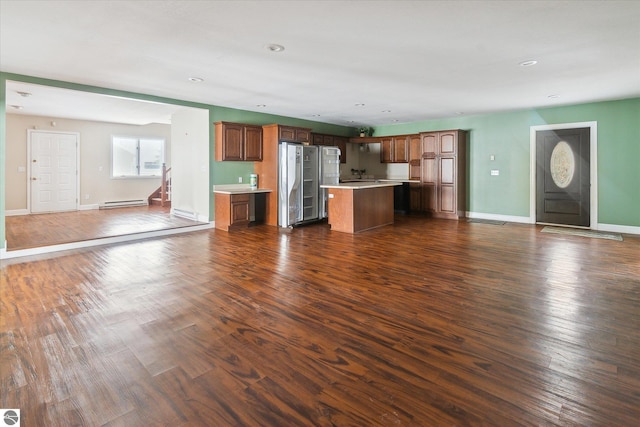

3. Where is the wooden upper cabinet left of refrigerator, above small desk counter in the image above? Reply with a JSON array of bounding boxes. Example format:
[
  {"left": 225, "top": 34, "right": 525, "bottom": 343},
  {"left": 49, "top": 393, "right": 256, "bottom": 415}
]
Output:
[{"left": 215, "top": 122, "right": 262, "bottom": 162}]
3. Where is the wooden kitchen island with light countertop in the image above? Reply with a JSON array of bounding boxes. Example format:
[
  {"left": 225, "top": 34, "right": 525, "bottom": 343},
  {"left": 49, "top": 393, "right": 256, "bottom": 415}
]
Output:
[{"left": 320, "top": 181, "right": 401, "bottom": 233}]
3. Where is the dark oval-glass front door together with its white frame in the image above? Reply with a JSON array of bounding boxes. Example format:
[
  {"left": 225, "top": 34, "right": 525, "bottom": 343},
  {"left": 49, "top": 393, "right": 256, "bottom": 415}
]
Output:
[{"left": 529, "top": 122, "right": 598, "bottom": 229}]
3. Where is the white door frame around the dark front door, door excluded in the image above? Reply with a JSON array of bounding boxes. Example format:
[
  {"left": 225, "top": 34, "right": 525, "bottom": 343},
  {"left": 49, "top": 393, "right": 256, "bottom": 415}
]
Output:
[{"left": 529, "top": 122, "right": 598, "bottom": 230}]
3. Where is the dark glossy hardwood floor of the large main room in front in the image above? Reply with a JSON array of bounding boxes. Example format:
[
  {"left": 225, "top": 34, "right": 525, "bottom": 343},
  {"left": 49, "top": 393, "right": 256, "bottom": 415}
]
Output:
[{"left": 0, "top": 216, "right": 640, "bottom": 426}]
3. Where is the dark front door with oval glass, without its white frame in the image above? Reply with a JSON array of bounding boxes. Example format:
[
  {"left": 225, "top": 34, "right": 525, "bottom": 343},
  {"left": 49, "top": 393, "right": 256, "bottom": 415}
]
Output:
[{"left": 536, "top": 128, "right": 591, "bottom": 227}]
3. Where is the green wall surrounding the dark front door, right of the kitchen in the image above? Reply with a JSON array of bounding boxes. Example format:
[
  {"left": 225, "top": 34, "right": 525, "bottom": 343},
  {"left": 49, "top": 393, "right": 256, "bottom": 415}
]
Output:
[{"left": 374, "top": 98, "right": 640, "bottom": 227}]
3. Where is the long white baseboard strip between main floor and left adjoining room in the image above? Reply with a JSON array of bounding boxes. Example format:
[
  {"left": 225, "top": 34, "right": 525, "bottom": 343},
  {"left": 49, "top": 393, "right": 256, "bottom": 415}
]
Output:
[{"left": 0, "top": 223, "right": 214, "bottom": 259}]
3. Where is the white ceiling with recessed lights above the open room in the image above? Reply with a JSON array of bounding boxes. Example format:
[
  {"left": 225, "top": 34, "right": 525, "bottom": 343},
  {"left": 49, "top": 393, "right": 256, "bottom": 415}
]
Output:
[{"left": 0, "top": 0, "right": 640, "bottom": 126}]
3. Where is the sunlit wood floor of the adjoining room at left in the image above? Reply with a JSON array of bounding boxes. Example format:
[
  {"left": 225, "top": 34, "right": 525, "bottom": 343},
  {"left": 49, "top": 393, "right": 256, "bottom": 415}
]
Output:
[{"left": 5, "top": 206, "right": 202, "bottom": 250}]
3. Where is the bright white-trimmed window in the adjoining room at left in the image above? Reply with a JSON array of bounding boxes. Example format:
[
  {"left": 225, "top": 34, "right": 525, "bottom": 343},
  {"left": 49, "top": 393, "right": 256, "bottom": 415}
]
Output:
[{"left": 111, "top": 136, "right": 164, "bottom": 178}]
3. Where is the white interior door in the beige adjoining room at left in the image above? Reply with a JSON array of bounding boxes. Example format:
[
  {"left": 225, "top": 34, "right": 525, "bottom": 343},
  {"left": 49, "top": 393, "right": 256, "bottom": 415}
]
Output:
[{"left": 29, "top": 131, "right": 78, "bottom": 213}]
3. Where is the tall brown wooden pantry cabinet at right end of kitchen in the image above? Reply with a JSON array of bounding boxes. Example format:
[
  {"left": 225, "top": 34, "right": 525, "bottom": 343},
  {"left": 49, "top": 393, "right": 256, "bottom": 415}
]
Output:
[{"left": 420, "top": 130, "right": 467, "bottom": 219}]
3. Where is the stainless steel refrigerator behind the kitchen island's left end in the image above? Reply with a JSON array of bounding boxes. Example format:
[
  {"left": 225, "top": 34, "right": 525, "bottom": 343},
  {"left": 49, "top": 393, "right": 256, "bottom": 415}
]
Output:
[{"left": 278, "top": 142, "right": 340, "bottom": 227}]
